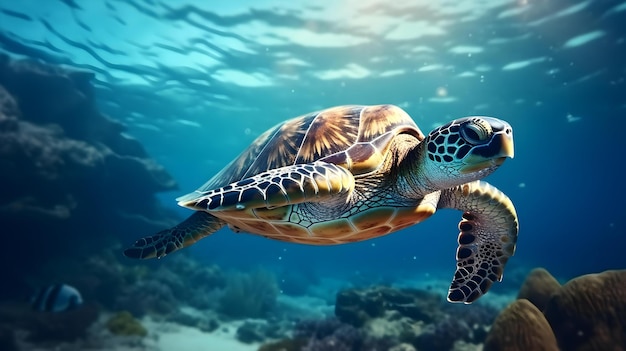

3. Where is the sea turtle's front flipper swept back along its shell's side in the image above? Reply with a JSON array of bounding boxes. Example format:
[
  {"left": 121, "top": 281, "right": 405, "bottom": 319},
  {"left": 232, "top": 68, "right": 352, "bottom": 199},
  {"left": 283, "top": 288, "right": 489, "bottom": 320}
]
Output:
[{"left": 177, "top": 161, "right": 354, "bottom": 211}]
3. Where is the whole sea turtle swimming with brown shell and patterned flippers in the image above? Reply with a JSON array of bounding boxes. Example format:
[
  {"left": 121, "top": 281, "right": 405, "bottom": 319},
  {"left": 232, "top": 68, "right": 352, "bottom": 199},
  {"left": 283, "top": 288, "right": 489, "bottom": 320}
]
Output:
[{"left": 124, "top": 105, "right": 518, "bottom": 303}]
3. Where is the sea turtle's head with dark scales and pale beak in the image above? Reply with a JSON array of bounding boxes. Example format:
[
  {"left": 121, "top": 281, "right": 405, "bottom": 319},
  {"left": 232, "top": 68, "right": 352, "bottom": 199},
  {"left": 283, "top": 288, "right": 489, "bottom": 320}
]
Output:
[{"left": 422, "top": 116, "right": 513, "bottom": 189}]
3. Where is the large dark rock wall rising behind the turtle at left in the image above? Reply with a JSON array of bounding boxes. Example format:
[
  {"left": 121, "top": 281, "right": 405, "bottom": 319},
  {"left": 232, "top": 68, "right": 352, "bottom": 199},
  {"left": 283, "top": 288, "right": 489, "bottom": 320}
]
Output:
[{"left": 0, "top": 54, "right": 177, "bottom": 298}]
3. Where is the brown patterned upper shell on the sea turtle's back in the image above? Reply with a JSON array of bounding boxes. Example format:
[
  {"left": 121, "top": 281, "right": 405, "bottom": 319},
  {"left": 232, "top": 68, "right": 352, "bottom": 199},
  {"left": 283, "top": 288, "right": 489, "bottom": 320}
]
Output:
[{"left": 190, "top": 105, "right": 424, "bottom": 192}]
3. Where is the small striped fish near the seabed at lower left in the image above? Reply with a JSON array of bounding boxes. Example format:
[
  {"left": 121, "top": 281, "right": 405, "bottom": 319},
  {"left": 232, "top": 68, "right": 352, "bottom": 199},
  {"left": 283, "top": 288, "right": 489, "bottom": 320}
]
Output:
[{"left": 31, "top": 284, "right": 83, "bottom": 312}]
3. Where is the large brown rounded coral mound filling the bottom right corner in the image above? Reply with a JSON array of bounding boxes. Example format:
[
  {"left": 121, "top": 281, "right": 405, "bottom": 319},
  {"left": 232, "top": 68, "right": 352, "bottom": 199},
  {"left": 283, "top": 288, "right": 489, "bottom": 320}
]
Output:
[{"left": 544, "top": 270, "right": 626, "bottom": 351}]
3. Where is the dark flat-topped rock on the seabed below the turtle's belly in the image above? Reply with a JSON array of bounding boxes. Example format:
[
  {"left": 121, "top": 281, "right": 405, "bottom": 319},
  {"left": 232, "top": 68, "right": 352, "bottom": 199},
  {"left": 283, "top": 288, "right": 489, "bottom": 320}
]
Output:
[{"left": 335, "top": 286, "right": 443, "bottom": 327}]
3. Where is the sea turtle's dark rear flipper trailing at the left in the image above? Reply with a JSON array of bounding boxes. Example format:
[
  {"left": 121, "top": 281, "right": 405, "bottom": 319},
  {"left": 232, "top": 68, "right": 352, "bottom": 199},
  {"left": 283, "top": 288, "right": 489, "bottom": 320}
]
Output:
[{"left": 124, "top": 212, "right": 225, "bottom": 259}]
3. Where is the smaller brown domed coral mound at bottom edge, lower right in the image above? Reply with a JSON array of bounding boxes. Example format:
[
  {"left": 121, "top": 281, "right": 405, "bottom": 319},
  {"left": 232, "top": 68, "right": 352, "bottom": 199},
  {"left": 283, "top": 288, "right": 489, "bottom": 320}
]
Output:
[{"left": 484, "top": 299, "right": 559, "bottom": 351}]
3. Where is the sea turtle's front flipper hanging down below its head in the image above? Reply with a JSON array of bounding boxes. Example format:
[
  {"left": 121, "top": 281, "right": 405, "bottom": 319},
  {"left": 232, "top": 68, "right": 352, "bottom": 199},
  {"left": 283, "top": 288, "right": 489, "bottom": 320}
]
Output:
[{"left": 438, "top": 181, "right": 518, "bottom": 304}]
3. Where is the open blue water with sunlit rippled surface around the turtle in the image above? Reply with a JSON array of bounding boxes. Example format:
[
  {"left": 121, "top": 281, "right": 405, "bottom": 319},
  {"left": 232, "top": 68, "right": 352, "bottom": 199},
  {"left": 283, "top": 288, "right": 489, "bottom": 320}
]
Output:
[{"left": 0, "top": 0, "right": 626, "bottom": 291}]
